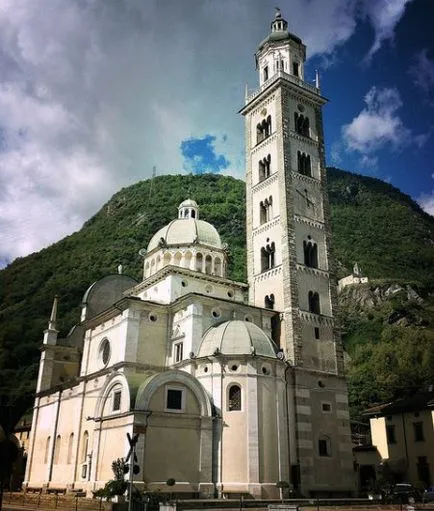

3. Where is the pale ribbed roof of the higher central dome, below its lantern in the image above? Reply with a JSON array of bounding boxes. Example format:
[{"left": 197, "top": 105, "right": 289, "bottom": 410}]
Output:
[{"left": 148, "top": 219, "right": 223, "bottom": 252}]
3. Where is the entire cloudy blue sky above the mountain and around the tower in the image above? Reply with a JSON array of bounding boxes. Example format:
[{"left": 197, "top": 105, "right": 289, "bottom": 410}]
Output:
[{"left": 0, "top": 0, "right": 434, "bottom": 267}]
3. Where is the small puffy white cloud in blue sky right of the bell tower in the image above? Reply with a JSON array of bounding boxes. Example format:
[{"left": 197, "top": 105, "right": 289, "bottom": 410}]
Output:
[{"left": 342, "top": 87, "right": 411, "bottom": 155}]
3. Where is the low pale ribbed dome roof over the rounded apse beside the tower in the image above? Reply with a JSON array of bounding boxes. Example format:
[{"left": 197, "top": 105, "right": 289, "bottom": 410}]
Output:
[{"left": 197, "top": 320, "right": 277, "bottom": 358}]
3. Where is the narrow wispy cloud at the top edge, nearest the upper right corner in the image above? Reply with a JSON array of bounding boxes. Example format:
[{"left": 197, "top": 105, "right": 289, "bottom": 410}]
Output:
[{"left": 363, "top": 0, "right": 414, "bottom": 58}]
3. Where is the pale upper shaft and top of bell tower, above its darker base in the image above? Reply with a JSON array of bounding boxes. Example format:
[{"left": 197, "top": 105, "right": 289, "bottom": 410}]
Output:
[{"left": 241, "top": 10, "right": 343, "bottom": 374}]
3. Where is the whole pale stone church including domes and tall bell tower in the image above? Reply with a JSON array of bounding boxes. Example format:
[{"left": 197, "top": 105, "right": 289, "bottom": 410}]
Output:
[{"left": 24, "top": 11, "right": 355, "bottom": 498}]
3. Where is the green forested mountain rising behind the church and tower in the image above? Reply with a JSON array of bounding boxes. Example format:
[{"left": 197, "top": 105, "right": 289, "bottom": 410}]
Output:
[{"left": 0, "top": 168, "right": 434, "bottom": 426}]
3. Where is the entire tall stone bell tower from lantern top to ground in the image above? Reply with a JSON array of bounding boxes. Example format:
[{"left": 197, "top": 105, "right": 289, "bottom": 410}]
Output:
[{"left": 241, "top": 10, "right": 353, "bottom": 493}]
